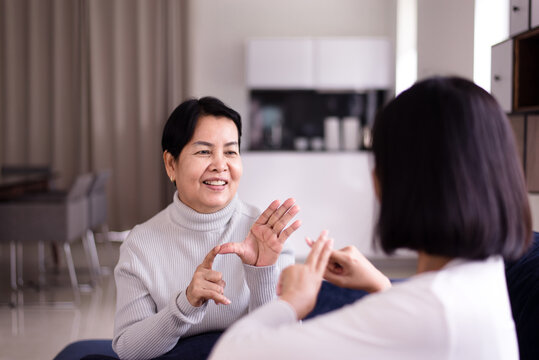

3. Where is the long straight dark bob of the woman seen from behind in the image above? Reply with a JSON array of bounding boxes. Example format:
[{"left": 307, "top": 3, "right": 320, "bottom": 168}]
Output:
[{"left": 373, "top": 77, "right": 532, "bottom": 259}]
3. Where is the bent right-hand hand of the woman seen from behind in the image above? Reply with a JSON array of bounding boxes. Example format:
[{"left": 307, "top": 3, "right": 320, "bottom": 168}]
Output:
[{"left": 306, "top": 239, "right": 391, "bottom": 292}]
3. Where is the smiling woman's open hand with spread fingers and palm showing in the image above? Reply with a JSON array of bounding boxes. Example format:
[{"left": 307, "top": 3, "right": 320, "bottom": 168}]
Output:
[{"left": 219, "top": 198, "right": 301, "bottom": 266}]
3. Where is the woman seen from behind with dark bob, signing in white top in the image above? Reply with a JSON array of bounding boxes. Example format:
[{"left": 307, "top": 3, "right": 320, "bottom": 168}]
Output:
[{"left": 211, "top": 78, "right": 532, "bottom": 360}]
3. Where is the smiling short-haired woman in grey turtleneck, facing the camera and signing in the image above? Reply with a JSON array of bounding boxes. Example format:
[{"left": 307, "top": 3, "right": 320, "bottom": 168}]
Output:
[{"left": 113, "top": 97, "right": 300, "bottom": 359}]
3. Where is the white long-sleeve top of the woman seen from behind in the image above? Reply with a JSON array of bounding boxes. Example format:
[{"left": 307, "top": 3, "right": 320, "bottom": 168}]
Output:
[{"left": 210, "top": 257, "right": 519, "bottom": 360}]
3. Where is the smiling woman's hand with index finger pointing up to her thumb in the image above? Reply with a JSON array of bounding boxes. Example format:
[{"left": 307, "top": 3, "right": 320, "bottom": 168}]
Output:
[{"left": 185, "top": 246, "right": 230, "bottom": 307}]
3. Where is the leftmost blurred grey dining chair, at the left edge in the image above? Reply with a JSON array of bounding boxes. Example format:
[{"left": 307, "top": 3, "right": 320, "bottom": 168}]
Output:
[{"left": 0, "top": 174, "right": 94, "bottom": 305}]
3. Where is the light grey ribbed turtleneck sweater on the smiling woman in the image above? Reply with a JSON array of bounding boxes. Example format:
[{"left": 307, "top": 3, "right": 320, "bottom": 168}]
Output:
[{"left": 112, "top": 193, "right": 294, "bottom": 359}]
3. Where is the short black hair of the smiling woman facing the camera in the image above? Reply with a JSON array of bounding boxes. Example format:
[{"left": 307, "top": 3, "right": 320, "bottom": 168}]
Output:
[{"left": 161, "top": 96, "right": 241, "bottom": 159}]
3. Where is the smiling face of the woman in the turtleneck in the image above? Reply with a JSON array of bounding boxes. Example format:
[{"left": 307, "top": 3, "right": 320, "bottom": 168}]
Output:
[{"left": 171, "top": 115, "right": 243, "bottom": 213}]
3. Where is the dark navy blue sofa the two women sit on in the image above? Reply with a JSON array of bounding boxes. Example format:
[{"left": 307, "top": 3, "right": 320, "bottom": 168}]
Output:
[{"left": 54, "top": 233, "right": 539, "bottom": 360}]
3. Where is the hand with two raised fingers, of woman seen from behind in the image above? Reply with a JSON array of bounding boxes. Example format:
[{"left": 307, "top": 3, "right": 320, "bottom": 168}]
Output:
[{"left": 277, "top": 232, "right": 333, "bottom": 319}]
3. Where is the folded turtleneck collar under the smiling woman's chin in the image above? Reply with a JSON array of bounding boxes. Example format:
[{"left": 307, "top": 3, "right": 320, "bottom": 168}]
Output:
[{"left": 169, "top": 191, "right": 239, "bottom": 231}]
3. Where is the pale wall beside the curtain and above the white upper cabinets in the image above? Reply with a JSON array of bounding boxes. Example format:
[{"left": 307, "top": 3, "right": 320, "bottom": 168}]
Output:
[{"left": 187, "top": 0, "right": 396, "bottom": 148}]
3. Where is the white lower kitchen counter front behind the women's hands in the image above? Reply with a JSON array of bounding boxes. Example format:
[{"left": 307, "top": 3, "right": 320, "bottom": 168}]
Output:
[{"left": 238, "top": 152, "right": 410, "bottom": 260}]
